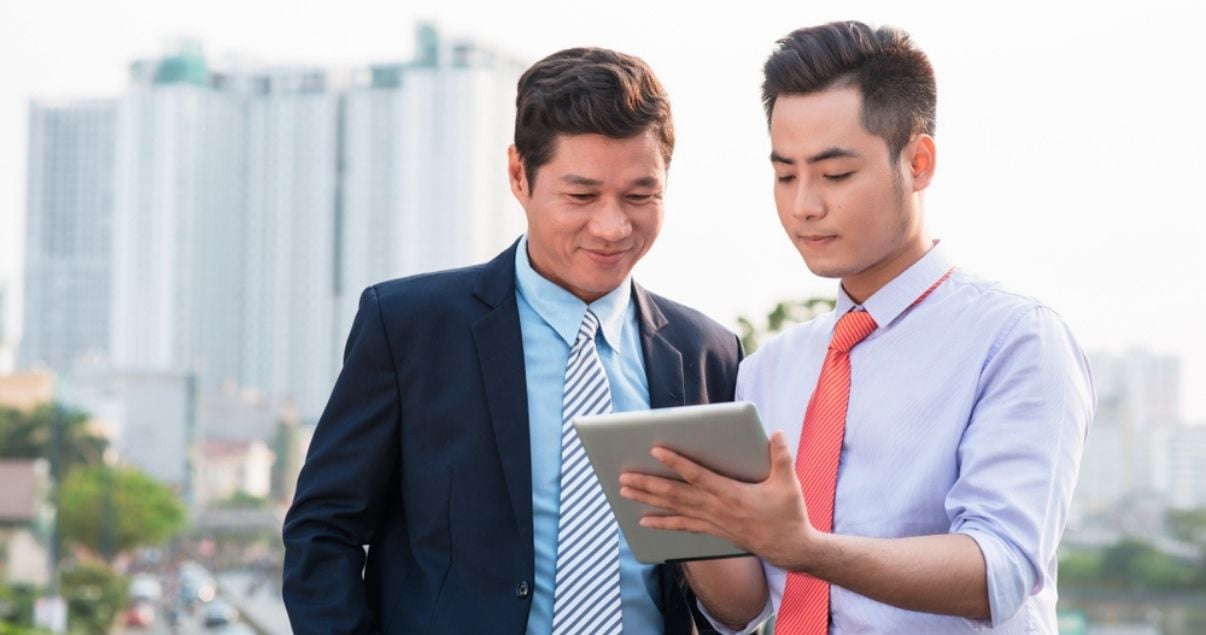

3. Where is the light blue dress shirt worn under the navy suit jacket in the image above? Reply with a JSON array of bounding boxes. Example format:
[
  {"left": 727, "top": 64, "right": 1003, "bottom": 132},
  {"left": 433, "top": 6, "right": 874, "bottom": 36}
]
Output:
[{"left": 515, "top": 236, "right": 665, "bottom": 635}]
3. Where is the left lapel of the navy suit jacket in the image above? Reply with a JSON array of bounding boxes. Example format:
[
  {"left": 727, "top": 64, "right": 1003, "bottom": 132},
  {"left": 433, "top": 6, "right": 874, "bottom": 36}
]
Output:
[{"left": 473, "top": 245, "right": 532, "bottom": 545}]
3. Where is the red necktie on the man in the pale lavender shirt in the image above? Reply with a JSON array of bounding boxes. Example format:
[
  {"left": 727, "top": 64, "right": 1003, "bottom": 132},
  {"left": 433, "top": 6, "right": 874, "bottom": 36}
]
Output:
[{"left": 774, "top": 267, "right": 954, "bottom": 635}]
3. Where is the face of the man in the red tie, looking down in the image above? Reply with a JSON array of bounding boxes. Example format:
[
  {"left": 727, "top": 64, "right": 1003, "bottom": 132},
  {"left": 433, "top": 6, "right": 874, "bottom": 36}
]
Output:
[{"left": 771, "top": 87, "right": 935, "bottom": 302}]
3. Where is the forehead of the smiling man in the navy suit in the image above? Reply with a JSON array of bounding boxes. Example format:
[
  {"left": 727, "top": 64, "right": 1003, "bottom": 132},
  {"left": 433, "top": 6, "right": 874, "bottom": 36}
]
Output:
[{"left": 541, "top": 130, "right": 666, "bottom": 181}]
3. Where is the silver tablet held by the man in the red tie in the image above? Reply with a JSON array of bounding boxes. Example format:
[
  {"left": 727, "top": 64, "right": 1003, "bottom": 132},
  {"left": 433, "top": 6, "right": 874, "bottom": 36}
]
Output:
[{"left": 574, "top": 401, "right": 771, "bottom": 564}]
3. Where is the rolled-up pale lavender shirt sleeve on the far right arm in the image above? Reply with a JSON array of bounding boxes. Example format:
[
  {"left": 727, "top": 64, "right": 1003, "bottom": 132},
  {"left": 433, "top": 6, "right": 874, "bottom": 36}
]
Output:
[{"left": 946, "top": 306, "right": 1095, "bottom": 627}]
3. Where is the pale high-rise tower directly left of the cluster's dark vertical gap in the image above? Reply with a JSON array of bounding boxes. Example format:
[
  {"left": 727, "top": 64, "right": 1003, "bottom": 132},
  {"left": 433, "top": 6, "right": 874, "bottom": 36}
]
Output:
[{"left": 241, "top": 69, "right": 340, "bottom": 417}]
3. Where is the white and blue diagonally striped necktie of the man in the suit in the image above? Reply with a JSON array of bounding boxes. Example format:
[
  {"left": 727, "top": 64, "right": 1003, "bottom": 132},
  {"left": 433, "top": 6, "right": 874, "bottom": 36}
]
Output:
[{"left": 552, "top": 310, "right": 622, "bottom": 635}]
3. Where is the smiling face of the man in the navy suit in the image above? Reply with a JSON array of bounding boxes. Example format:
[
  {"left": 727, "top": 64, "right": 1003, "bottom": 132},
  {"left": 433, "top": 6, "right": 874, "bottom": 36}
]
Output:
[{"left": 509, "top": 131, "right": 666, "bottom": 302}]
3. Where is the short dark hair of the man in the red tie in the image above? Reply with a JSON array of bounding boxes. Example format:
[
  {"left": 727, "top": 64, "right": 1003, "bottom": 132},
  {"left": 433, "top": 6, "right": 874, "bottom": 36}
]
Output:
[{"left": 762, "top": 20, "right": 938, "bottom": 164}]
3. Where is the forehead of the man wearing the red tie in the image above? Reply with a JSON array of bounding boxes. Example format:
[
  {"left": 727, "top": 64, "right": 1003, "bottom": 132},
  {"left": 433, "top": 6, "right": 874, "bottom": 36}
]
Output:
[{"left": 771, "top": 87, "right": 879, "bottom": 158}]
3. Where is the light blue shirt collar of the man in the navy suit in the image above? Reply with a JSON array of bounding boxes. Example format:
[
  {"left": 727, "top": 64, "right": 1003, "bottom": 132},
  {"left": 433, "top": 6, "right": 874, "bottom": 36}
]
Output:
[{"left": 515, "top": 235, "right": 632, "bottom": 352}]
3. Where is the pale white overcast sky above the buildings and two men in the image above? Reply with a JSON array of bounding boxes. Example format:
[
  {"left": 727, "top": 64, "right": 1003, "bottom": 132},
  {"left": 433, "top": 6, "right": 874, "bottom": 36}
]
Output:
[{"left": 0, "top": 0, "right": 1206, "bottom": 421}]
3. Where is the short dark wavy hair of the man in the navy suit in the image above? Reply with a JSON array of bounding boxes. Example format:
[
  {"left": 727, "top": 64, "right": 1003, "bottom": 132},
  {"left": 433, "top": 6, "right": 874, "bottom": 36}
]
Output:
[{"left": 515, "top": 48, "right": 674, "bottom": 187}]
